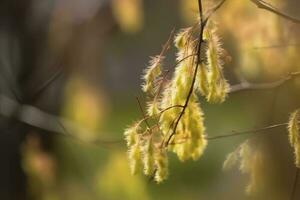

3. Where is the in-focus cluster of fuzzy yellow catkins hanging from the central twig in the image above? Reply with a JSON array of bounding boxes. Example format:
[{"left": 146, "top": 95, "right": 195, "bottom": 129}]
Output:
[{"left": 125, "top": 20, "right": 229, "bottom": 183}]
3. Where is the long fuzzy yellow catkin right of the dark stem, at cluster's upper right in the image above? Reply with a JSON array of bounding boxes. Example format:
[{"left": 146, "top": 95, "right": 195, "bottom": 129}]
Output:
[{"left": 204, "top": 22, "right": 229, "bottom": 103}]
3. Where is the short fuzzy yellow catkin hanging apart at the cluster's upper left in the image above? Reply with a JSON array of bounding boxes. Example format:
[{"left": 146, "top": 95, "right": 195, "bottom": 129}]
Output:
[{"left": 142, "top": 56, "right": 164, "bottom": 93}]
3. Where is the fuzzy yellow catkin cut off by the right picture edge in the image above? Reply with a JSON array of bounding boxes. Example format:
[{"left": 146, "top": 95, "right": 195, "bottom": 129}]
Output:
[{"left": 288, "top": 109, "right": 300, "bottom": 168}]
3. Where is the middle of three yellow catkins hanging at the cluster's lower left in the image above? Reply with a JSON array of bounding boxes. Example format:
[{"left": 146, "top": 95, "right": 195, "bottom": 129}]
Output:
[{"left": 143, "top": 139, "right": 154, "bottom": 176}]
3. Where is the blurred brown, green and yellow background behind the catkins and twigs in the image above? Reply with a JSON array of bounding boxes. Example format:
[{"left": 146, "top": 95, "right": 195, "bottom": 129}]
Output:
[{"left": 0, "top": 0, "right": 300, "bottom": 200}]
